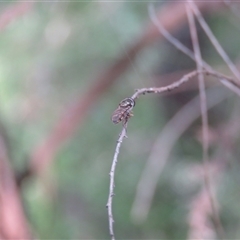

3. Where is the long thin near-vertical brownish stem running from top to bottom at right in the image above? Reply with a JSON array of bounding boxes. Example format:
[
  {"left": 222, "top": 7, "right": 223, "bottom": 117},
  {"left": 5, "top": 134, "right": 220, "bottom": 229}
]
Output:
[{"left": 186, "top": 3, "right": 222, "bottom": 237}]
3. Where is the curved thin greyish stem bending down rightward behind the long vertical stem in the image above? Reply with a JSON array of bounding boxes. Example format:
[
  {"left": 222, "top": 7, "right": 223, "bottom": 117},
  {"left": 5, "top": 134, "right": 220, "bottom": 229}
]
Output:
[{"left": 148, "top": 4, "right": 240, "bottom": 96}]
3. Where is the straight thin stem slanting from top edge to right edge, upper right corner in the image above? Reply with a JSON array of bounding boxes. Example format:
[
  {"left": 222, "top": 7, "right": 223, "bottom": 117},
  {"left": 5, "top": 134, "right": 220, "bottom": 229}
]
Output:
[{"left": 190, "top": 2, "right": 240, "bottom": 81}]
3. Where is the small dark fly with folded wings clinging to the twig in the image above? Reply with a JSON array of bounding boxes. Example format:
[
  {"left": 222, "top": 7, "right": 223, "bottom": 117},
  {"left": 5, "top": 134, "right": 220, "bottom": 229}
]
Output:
[{"left": 112, "top": 98, "right": 135, "bottom": 124}]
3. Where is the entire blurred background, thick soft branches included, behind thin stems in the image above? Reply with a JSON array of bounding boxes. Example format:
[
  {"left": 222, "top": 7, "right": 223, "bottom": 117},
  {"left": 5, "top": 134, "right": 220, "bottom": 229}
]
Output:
[{"left": 0, "top": 1, "right": 240, "bottom": 239}]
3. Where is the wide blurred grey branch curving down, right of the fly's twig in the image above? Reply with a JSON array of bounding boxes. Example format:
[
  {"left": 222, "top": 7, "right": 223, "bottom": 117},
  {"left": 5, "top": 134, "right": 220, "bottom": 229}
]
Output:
[{"left": 131, "top": 86, "right": 232, "bottom": 223}]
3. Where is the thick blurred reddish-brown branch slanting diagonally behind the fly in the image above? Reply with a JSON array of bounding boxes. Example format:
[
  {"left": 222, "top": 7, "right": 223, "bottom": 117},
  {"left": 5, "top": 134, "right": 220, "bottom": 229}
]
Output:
[{"left": 26, "top": 2, "right": 219, "bottom": 180}]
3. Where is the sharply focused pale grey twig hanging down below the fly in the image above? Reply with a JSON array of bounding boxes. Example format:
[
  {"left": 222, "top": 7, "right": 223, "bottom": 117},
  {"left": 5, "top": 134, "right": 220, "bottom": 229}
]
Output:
[{"left": 106, "top": 122, "right": 127, "bottom": 240}]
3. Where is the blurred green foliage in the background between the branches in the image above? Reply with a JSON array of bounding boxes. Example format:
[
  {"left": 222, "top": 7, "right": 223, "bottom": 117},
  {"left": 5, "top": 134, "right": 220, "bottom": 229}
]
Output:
[{"left": 0, "top": 1, "right": 240, "bottom": 239}]
